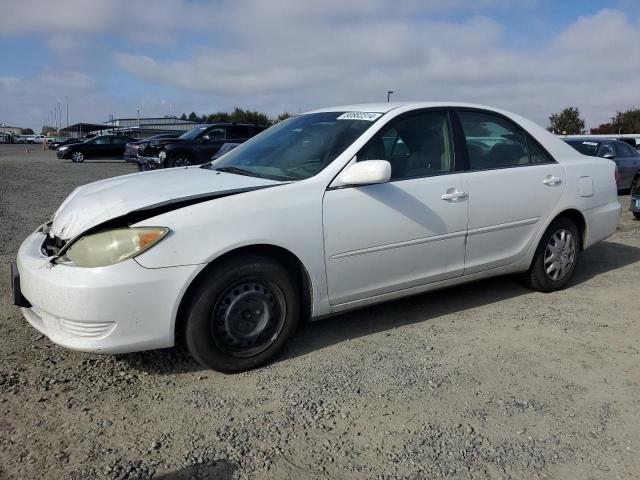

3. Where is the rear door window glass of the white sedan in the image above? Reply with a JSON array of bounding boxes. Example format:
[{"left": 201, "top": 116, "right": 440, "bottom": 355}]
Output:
[{"left": 459, "top": 111, "right": 533, "bottom": 170}]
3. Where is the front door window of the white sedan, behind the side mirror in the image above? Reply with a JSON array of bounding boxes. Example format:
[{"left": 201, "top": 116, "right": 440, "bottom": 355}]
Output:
[{"left": 357, "top": 110, "right": 454, "bottom": 181}]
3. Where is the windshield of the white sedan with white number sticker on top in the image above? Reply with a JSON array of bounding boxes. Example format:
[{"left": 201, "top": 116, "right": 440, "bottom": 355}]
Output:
[{"left": 204, "top": 112, "right": 382, "bottom": 180}]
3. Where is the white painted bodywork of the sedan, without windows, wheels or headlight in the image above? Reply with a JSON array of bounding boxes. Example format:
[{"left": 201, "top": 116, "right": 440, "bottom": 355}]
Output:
[{"left": 18, "top": 103, "right": 620, "bottom": 352}]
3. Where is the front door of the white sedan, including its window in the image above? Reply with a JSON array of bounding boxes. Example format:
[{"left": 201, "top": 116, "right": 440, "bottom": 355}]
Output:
[{"left": 323, "top": 109, "right": 468, "bottom": 305}]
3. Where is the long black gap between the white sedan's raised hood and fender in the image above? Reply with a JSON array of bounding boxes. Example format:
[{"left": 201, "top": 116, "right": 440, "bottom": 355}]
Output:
[{"left": 57, "top": 182, "right": 290, "bottom": 257}]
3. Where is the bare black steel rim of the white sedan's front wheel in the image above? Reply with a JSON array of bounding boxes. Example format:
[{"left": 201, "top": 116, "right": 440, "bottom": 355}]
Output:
[{"left": 212, "top": 280, "right": 286, "bottom": 357}]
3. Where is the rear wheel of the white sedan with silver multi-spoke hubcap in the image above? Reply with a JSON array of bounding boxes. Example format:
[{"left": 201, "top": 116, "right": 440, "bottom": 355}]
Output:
[{"left": 525, "top": 217, "right": 580, "bottom": 292}]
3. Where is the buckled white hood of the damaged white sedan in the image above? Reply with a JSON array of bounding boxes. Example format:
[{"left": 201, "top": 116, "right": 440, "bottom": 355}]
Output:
[{"left": 49, "top": 167, "right": 284, "bottom": 240}]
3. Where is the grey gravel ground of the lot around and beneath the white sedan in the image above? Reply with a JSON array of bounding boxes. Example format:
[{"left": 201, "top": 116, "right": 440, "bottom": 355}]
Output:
[{"left": 0, "top": 145, "right": 640, "bottom": 480}]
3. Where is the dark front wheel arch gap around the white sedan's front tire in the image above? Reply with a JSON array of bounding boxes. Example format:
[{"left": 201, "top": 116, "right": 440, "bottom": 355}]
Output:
[{"left": 174, "top": 243, "right": 313, "bottom": 344}]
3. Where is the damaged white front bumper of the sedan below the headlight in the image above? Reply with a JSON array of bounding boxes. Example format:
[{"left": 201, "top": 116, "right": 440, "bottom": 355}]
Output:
[{"left": 17, "top": 229, "right": 200, "bottom": 353}]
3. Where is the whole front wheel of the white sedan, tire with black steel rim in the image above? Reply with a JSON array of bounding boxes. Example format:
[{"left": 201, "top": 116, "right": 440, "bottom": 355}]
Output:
[{"left": 184, "top": 254, "right": 300, "bottom": 373}]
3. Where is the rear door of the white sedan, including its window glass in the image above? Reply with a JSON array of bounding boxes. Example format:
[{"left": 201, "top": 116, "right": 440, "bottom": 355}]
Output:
[{"left": 458, "top": 109, "right": 566, "bottom": 275}]
